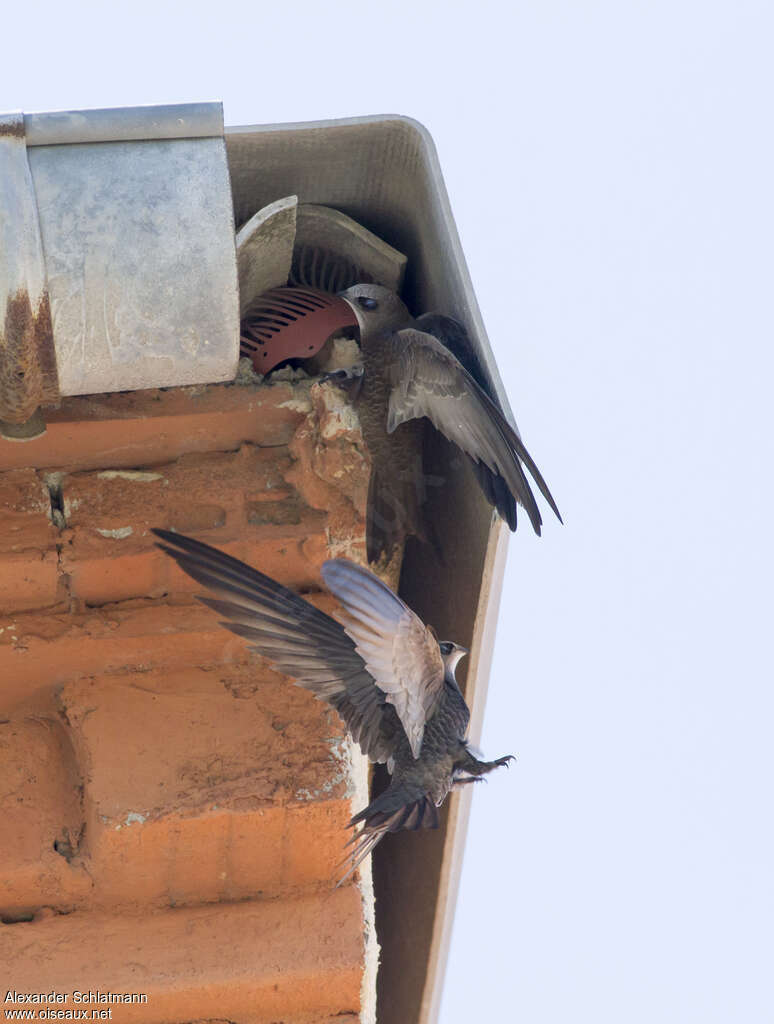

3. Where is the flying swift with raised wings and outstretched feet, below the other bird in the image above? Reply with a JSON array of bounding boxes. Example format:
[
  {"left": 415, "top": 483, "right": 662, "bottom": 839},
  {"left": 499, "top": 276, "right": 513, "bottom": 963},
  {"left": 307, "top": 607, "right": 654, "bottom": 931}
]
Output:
[{"left": 154, "top": 529, "right": 513, "bottom": 884}]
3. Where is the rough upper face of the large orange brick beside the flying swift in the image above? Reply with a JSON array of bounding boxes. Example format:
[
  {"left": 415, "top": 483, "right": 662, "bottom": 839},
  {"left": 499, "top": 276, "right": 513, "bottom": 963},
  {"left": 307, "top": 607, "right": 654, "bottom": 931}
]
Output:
[{"left": 59, "top": 664, "right": 343, "bottom": 824}]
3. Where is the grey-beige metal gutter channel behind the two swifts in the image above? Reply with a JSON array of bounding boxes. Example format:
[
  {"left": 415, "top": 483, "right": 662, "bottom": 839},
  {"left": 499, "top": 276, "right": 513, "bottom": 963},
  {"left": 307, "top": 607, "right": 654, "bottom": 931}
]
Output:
[{"left": 226, "top": 115, "right": 512, "bottom": 1024}]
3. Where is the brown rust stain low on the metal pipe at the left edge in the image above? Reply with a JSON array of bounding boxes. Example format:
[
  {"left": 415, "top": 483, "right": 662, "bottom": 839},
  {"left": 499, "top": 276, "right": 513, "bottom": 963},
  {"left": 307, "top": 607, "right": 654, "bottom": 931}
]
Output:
[{"left": 0, "top": 289, "right": 59, "bottom": 423}]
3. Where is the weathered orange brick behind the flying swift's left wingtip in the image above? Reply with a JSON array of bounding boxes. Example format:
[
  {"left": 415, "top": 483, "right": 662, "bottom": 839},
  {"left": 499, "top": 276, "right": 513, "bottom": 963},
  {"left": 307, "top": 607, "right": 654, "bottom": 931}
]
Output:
[{"left": 61, "top": 445, "right": 337, "bottom": 605}]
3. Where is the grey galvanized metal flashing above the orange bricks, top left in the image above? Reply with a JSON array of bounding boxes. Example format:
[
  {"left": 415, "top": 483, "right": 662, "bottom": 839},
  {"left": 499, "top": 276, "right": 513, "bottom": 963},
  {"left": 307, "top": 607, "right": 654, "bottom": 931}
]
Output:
[{"left": 0, "top": 103, "right": 240, "bottom": 418}]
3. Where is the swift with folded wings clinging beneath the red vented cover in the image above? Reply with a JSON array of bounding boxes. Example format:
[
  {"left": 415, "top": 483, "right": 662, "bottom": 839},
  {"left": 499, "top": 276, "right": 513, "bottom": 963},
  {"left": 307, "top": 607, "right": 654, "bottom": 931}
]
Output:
[{"left": 337, "top": 285, "right": 561, "bottom": 562}]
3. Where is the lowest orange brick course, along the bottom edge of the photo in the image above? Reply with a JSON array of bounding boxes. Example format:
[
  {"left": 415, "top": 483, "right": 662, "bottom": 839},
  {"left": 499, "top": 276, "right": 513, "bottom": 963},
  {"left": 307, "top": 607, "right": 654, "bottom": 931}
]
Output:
[{"left": 0, "top": 886, "right": 363, "bottom": 1024}]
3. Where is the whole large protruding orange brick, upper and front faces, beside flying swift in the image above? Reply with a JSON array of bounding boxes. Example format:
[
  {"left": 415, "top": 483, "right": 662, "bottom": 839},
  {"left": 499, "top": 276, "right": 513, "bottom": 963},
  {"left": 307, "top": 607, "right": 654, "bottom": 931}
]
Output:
[{"left": 60, "top": 665, "right": 352, "bottom": 905}]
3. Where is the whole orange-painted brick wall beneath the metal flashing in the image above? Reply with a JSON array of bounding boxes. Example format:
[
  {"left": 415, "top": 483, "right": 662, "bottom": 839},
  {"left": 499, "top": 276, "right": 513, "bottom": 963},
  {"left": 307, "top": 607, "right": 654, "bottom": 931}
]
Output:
[{"left": 0, "top": 381, "right": 382, "bottom": 1024}]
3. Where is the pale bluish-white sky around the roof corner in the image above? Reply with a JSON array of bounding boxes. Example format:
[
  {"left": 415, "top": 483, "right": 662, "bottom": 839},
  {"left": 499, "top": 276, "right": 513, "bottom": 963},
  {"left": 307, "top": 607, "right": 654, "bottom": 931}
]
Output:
[{"left": 0, "top": 0, "right": 774, "bottom": 1024}]
